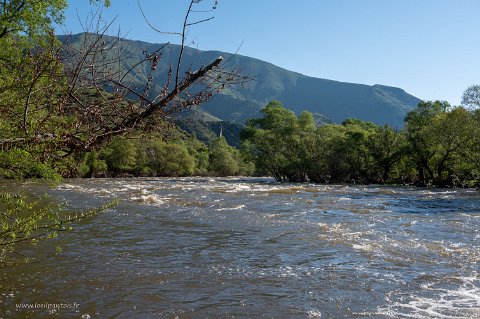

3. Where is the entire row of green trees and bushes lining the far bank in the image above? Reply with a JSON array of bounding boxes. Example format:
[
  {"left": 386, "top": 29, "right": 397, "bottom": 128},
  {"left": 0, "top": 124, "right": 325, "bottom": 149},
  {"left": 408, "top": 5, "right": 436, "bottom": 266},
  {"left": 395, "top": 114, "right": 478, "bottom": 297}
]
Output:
[{"left": 72, "top": 97, "right": 480, "bottom": 187}]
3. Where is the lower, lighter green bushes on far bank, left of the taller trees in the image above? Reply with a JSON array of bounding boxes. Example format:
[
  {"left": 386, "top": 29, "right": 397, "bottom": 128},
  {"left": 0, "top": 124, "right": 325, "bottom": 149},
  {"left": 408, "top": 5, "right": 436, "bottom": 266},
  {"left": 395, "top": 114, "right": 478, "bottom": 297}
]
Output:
[{"left": 76, "top": 133, "right": 254, "bottom": 177}]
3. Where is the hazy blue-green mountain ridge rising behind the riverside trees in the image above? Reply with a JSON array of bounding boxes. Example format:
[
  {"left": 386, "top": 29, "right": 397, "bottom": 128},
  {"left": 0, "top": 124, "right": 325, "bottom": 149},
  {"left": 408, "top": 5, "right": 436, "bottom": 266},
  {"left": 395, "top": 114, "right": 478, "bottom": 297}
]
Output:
[{"left": 60, "top": 34, "right": 420, "bottom": 128}]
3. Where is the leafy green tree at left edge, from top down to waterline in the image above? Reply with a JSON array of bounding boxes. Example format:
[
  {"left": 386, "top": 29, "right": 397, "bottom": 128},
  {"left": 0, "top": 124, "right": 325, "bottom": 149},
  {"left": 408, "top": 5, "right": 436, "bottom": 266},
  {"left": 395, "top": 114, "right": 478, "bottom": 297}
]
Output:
[{"left": 0, "top": 0, "right": 108, "bottom": 177}]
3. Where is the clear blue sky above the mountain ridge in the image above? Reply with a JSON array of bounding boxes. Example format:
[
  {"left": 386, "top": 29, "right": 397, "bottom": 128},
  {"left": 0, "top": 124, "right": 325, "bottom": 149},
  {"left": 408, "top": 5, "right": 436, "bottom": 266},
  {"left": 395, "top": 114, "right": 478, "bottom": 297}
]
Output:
[{"left": 58, "top": 0, "right": 480, "bottom": 105}]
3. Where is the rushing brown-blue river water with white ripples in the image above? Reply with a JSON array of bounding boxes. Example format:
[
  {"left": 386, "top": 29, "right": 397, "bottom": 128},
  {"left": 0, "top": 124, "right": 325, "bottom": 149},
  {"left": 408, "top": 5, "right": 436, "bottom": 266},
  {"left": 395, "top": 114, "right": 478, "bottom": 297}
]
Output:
[{"left": 0, "top": 178, "right": 480, "bottom": 318}]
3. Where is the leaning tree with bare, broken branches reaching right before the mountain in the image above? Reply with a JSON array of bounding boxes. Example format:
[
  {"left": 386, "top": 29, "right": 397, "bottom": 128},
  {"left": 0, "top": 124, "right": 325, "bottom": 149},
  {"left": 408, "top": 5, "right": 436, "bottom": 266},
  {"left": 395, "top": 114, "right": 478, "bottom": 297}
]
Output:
[{"left": 0, "top": 0, "right": 248, "bottom": 178}]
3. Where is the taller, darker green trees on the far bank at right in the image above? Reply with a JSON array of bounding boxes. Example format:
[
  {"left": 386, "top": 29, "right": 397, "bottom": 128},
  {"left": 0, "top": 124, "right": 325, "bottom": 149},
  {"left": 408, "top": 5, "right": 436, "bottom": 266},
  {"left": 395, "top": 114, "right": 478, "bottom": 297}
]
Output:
[{"left": 241, "top": 101, "right": 480, "bottom": 186}]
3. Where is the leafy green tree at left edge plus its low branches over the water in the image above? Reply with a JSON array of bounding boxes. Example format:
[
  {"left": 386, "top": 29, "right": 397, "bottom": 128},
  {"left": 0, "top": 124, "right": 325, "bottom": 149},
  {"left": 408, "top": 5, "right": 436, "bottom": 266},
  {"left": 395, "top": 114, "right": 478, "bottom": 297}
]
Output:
[{"left": 0, "top": 0, "right": 113, "bottom": 266}]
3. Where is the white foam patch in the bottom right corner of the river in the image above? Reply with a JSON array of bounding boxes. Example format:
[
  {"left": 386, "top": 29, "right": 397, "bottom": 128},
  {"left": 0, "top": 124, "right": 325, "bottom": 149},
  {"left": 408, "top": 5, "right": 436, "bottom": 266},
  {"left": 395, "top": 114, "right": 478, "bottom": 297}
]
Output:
[{"left": 376, "top": 276, "right": 480, "bottom": 319}]
